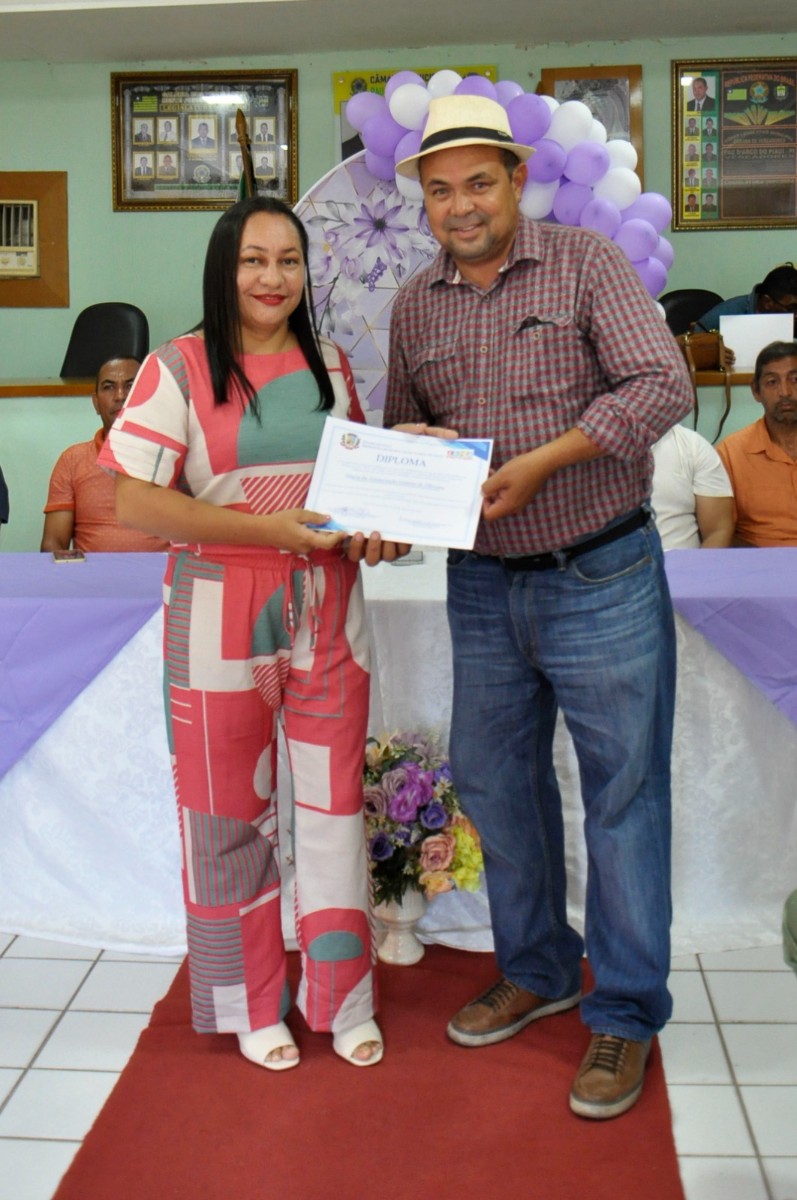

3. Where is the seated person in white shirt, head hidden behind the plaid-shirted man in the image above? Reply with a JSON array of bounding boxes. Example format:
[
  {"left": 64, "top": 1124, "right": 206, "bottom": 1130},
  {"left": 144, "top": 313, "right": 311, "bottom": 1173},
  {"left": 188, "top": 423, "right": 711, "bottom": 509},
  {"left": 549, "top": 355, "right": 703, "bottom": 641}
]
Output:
[{"left": 651, "top": 425, "right": 733, "bottom": 550}]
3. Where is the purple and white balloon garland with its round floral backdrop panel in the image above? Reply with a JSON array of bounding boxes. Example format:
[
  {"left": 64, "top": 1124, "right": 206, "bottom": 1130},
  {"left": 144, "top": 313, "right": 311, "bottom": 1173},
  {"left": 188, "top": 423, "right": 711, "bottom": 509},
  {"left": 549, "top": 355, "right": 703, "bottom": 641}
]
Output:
[{"left": 296, "top": 70, "right": 675, "bottom": 424}]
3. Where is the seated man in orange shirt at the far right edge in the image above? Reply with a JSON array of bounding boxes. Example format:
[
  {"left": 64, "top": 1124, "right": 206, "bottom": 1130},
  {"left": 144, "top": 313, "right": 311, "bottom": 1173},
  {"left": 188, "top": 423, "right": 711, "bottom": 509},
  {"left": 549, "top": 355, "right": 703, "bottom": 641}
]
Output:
[{"left": 717, "top": 342, "right": 797, "bottom": 546}]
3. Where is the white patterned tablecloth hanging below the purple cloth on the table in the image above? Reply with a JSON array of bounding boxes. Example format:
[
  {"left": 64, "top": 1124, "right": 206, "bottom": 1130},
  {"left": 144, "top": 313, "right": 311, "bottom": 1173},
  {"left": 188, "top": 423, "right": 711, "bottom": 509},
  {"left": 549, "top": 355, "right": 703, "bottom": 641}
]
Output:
[{"left": 0, "top": 551, "right": 797, "bottom": 954}]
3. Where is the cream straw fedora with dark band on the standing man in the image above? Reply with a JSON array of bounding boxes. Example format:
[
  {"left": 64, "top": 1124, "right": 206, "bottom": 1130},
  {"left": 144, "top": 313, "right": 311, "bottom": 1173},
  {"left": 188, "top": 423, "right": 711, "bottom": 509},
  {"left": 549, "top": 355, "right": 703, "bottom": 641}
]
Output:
[{"left": 396, "top": 96, "right": 534, "bottom": 179}]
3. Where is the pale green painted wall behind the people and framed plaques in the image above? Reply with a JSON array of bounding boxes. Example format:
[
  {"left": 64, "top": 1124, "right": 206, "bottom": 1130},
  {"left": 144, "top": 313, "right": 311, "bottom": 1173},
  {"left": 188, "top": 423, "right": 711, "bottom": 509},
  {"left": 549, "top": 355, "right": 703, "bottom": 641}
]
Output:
[{"left": 0, "top": 36, "right": 797, "bottom": 550}]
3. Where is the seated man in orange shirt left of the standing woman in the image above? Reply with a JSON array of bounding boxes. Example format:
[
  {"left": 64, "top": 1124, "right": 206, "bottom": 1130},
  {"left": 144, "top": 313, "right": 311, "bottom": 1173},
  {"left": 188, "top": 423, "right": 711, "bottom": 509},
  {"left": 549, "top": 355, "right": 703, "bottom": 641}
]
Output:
[{"left": 41, "top": 359, "right": 168, "bottom": 552}]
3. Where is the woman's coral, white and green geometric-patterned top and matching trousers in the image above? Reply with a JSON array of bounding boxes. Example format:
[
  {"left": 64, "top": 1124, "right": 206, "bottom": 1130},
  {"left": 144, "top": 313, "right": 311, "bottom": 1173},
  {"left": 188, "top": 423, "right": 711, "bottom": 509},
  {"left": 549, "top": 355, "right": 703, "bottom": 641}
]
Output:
[{"left": 103, "top": 336, "right": 374, "bottom": 1032}]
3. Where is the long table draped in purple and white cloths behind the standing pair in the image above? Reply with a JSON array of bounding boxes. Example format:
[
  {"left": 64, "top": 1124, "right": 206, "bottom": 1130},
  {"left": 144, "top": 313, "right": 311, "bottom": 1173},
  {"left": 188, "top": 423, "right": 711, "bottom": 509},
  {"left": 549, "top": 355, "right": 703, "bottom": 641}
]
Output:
[{"left": 0, "top": 550, "right": 797, "bottom": 954}]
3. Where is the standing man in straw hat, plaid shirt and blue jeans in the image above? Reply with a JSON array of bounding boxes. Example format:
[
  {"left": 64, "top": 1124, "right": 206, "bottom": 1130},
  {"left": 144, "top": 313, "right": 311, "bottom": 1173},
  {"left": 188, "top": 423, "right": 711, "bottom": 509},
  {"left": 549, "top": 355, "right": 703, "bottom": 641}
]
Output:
[{"left": 385, "top": 96, "right": 691, "bottom": 1118}]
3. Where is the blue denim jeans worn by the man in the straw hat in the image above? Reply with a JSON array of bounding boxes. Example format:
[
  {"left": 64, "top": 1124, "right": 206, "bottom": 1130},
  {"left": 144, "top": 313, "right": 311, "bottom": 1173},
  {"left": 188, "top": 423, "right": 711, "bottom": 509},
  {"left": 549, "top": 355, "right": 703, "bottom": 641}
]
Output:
[{"left": 448, "top": 523, "right": 676, "bottom": 1040}]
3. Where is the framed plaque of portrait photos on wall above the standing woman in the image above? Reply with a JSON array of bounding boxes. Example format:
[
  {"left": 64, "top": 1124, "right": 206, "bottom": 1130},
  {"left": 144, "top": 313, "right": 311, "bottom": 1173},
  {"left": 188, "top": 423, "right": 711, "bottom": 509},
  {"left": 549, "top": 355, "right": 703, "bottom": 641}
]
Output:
[{"left": 110, "top": 71, "right": 298, "bottom": 212}]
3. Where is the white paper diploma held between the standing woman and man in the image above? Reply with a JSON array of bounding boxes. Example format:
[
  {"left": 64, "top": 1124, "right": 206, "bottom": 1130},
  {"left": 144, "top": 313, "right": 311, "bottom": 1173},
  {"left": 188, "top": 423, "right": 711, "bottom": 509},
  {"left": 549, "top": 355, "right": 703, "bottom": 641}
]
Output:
[{"left": 306, "top": 416, "right": 492, "bottom": 550}]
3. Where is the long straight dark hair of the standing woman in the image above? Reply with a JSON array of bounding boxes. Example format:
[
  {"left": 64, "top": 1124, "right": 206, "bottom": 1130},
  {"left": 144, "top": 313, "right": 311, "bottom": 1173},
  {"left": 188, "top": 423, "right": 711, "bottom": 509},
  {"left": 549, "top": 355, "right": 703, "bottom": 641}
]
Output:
[{"left": 200, "top": 196, "right": 335, "bottom": 414}]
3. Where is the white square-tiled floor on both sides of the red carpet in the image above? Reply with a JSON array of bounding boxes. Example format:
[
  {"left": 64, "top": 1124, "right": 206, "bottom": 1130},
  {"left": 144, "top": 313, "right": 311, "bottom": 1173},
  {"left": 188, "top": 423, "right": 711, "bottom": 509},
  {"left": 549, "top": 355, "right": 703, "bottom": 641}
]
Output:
[{"left": 0, "top": 934, "right": 797, "bottom": 1200}]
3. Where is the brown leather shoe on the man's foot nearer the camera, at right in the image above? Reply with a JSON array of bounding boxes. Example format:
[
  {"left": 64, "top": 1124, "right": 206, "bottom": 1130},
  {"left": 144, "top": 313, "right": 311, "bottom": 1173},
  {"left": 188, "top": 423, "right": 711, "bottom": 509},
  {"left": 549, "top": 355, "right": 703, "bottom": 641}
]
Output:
[{"left": 570, "top": 1033, "right": 651, "bottom": 1121}]
